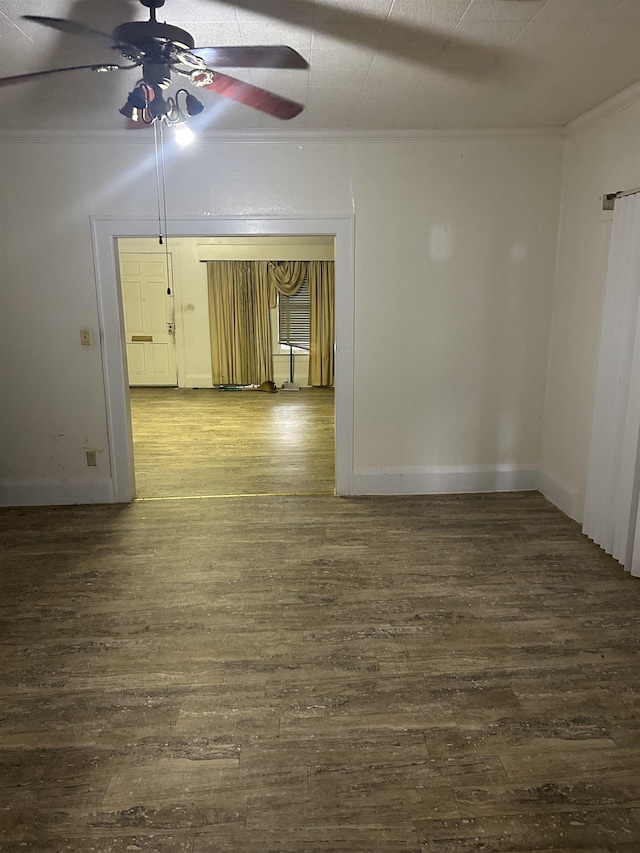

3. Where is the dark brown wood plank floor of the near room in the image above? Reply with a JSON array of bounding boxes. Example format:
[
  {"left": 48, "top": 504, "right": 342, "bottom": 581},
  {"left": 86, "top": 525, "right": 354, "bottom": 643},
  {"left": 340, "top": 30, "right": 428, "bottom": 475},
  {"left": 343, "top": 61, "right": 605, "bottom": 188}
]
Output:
[{"left": 0, "top": 486, "right": 640, "bottom": 853}]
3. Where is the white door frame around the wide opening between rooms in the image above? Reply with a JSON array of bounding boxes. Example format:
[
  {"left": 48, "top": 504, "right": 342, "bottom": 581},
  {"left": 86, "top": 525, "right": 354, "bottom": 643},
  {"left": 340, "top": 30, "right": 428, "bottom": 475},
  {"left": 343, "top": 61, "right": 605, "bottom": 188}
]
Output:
[{"left": 90, "top": 215, "right": 355, "bottom": 503}]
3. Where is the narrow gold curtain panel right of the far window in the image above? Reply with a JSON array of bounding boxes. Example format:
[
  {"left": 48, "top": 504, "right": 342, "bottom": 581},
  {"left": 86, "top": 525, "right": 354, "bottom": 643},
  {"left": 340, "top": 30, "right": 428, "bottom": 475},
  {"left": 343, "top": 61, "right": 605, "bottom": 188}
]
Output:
[{"left": 308, "top": 261, "right": 335, "bottom": 385}]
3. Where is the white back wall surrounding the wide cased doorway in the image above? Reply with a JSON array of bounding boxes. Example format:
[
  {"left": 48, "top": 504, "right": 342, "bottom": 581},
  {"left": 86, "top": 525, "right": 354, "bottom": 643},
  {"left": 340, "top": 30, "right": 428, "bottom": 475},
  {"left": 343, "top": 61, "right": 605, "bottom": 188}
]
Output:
[{"left": 0, "top": 132, "right": 562, "bottom": 503}]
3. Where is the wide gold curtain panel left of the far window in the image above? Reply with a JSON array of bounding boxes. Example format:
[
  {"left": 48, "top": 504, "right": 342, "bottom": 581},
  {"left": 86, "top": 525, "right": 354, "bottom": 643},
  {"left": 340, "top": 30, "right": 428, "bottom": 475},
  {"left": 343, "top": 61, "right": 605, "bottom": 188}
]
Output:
[{"left": 207, "top": 261, "right": 273, "bottom": 385}]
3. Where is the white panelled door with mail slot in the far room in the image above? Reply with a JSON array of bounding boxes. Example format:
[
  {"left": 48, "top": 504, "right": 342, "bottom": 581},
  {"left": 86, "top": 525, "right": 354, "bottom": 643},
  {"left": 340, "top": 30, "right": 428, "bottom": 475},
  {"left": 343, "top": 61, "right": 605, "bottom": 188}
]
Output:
[{"left": 120, "top": 252, "right": 178, "bottom": 386}]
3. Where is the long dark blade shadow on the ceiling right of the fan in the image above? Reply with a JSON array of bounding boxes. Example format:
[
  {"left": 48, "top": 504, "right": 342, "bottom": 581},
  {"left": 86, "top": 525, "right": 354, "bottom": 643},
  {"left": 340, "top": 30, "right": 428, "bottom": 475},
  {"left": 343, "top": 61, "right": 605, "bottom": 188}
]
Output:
[{"left": 210, "top": 0, "right": 504, "bottom": 75}]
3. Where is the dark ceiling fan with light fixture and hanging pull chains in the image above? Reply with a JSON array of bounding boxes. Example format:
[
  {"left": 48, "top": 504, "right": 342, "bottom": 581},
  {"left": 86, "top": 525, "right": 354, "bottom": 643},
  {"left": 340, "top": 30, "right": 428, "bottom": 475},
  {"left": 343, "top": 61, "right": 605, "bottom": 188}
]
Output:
[{"left": 0, "top": 0, "right": 309, "bottom": 127}]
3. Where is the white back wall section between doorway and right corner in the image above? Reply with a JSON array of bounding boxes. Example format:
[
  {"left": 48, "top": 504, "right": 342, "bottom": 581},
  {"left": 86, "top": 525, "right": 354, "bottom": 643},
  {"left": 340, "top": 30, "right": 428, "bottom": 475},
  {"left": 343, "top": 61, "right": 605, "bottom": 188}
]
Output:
[{"left": 355, "top": 139, "right": 561, "bottom": 491}]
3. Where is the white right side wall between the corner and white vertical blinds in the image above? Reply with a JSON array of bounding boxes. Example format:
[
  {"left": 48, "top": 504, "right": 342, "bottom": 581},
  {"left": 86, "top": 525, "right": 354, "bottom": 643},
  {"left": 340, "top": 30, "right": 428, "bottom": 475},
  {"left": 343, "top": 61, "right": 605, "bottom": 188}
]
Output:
[{"left": 541, "top": 86, "right": 640, "bottom": 521}]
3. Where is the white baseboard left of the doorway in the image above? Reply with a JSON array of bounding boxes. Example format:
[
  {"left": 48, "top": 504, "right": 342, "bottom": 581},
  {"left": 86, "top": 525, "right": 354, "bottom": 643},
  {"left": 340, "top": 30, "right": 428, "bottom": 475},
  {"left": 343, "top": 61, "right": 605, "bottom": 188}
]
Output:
[{"left": 0, "top": 477, "right": 113, "bottom": 506}]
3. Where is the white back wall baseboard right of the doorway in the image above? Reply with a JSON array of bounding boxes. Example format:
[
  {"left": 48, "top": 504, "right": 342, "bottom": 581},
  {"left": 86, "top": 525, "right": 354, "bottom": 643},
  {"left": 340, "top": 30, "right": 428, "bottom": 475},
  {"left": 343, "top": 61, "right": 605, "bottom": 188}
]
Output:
[{"left": 351, "top": 465, "right": 538, "bottom": 495}]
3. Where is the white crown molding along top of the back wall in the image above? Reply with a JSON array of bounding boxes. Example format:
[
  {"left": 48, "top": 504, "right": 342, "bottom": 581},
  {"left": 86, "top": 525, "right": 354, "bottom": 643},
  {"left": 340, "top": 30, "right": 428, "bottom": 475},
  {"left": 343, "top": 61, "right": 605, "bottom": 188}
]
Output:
[{"left": 0, "top": 127, "right": 564, "bottom": 145}]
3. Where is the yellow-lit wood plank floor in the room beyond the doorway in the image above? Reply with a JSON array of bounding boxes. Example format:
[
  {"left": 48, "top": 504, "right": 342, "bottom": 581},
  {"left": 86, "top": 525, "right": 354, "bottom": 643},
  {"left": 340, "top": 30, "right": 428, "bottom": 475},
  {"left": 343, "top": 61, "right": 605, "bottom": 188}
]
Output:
[{"left": 130, "top": 388, "right": 335, "bottom": 498}]
